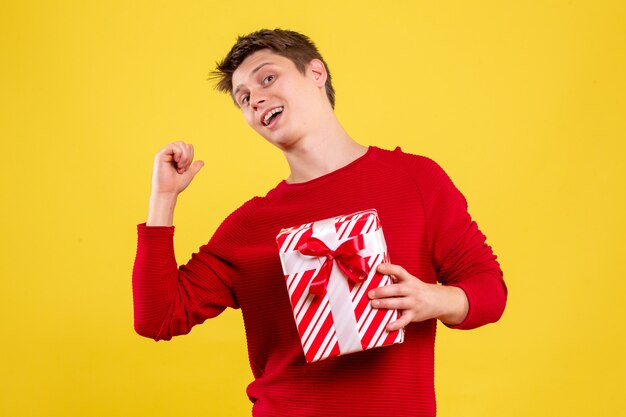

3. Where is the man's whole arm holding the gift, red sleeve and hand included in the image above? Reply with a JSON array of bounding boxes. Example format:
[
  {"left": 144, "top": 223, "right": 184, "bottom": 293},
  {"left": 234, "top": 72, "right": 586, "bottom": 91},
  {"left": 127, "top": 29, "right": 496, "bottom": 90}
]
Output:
[{"left": 369, "top": 157, "right": 507, "bottom": 331}]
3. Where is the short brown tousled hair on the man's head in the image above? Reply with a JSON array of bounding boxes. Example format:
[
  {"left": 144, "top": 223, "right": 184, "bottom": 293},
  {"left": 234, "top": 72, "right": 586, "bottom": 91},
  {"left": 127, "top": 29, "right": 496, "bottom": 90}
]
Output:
[{"left": 211, "top": 29, "right": 335, "bottom": 108}]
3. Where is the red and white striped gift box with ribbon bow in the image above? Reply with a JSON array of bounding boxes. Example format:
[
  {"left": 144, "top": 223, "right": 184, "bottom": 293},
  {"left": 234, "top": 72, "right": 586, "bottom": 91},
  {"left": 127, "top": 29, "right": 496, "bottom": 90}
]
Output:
[{"left": 276, "top": 209, "right": 404, "bottom": 362}]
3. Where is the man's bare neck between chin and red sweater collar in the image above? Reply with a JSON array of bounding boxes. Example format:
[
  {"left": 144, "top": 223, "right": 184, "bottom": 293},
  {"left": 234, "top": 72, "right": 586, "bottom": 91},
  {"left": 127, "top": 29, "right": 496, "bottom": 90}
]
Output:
[{"left": 283, "top": 114, "right": 367, "bottom": 183}]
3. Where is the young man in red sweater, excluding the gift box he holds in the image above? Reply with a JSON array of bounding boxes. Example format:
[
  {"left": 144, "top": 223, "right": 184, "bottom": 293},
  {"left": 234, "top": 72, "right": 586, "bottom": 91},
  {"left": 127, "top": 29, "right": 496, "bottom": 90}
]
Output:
[{"left": 133, "top": 29, "right": 507, "bottom": 417}]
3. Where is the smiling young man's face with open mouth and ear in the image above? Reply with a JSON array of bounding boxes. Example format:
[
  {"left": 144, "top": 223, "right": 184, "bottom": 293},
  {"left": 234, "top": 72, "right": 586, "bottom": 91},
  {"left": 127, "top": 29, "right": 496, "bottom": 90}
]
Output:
[{"left": 232, "top": 49, "right": 320, "bottom": 149}]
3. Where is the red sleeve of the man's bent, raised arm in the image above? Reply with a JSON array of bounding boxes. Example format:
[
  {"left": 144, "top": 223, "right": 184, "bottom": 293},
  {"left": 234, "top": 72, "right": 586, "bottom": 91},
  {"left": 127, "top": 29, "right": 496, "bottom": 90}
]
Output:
[{"left": 132, "top": 213, "right": 238, "bottom": 340}]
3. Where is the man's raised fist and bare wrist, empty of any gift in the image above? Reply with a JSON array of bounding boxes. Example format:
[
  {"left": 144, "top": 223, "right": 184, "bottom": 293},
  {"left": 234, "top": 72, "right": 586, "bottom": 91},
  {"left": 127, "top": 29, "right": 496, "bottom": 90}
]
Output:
[{"left": 146, "top": 142, "right": 204, "bottom": 226}]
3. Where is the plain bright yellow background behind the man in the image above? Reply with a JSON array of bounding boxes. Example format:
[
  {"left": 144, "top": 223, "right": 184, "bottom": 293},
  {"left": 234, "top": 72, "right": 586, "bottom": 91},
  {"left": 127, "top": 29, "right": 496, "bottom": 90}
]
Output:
[{"left": 0, "top": 0, "right": 626, "bottom": 417}]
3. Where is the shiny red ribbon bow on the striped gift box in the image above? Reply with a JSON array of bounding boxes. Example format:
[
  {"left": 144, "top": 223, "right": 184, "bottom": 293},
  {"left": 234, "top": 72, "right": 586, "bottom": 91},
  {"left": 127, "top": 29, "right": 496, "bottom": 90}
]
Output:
[{"left": 298, "top": 235, "right": 370, "bottom": 296}]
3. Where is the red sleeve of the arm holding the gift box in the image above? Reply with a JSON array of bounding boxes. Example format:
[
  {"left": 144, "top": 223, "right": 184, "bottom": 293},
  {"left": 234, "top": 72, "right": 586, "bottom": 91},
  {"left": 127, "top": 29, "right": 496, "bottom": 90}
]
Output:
[{"left": 410, "top": 158, "right": 507, "bottom": 329}]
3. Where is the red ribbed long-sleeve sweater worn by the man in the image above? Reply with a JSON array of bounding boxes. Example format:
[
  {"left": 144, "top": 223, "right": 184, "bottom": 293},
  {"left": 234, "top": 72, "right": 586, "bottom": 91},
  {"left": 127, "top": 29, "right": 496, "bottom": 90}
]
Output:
[{"left": 133, "top": 147, "right": 507, "bottom": 417}]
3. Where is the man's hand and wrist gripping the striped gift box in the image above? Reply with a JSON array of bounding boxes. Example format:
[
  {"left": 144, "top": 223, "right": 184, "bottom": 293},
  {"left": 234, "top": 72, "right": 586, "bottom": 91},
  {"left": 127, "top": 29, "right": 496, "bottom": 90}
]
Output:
[{"left": 368, "top": 264, "right": 469, "bottom": 331}]
